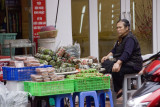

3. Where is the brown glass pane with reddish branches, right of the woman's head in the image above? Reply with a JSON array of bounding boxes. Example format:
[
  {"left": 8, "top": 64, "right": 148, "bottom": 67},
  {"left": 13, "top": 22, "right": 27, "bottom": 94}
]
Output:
[{"left": 130, "top": 0, "right": 153, "bottom": 54}]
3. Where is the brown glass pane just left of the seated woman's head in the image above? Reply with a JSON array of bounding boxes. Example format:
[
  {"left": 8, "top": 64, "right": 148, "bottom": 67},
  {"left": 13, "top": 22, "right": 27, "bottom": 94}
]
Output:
[{"left": 98, "top": 0, "right": 120, "bottom": 59}]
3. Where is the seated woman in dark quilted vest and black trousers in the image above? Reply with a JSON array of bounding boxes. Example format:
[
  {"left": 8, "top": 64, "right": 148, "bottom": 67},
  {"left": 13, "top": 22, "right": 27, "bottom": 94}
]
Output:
[{"left": 101, "top": 19, "right": 142, "bottom": 98}]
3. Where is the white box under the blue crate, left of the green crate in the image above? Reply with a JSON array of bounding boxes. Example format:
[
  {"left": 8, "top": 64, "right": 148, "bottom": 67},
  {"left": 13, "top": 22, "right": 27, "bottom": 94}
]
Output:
[{"left": 6, "top": 81, "right": 24, "bottom": 91}]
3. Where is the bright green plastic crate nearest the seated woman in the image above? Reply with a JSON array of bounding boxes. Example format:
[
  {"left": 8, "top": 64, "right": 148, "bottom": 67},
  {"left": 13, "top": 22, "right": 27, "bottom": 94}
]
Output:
[{"left": 74, "top": 76, "right": 110, "bottom": 92}]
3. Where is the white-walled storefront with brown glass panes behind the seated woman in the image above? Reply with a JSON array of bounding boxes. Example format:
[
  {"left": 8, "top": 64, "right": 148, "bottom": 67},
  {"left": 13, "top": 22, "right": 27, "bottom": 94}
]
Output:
[{"left": 47, "top": 0, "right": 160, "bottom": 58}]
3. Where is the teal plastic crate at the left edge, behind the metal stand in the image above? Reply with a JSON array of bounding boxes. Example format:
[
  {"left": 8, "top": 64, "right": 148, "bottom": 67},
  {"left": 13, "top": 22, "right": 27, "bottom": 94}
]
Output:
[{"left": 0, "top": 33, "right": 17, "bottom": 56}]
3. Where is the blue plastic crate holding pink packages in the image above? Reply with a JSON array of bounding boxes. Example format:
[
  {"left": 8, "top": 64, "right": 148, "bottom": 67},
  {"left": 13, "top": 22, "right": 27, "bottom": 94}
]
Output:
[{"left": 2, "top": 65, "right": 52, "bottom": 81}]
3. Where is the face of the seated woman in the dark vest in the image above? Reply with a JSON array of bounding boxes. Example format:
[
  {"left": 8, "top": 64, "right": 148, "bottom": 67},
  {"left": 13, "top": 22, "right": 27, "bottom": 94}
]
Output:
[{"left": 117, "top": 21, "right": 128, "bottom": 36}]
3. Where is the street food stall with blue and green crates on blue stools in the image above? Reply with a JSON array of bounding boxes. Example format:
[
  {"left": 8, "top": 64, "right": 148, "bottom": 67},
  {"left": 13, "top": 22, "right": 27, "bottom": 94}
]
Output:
[{"left": 2, "top": 25, "right": 113, "bottom": 107}]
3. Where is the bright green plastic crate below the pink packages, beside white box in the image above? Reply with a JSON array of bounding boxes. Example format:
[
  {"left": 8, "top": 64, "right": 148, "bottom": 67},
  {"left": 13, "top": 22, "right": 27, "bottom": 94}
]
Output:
[{"left": 24, "top": 79, "right": 74, "bottom": 96}]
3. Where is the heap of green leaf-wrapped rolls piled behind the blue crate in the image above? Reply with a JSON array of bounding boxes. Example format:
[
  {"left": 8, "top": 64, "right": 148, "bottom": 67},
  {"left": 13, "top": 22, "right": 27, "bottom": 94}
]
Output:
[{"left": 35, "top": 47, "right": 78, "bottom": 72}]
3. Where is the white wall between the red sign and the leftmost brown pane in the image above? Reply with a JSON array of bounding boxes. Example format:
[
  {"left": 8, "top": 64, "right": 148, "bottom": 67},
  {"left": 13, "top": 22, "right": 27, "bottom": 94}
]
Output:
[{"left": 46, "top": 0, "right": 72, "bottom": 46}]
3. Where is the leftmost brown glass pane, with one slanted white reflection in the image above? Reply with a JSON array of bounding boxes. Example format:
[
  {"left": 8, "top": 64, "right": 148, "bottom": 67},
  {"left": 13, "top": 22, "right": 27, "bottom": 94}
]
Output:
[{"left": 71, "top": 0, "right": 90, "bottom": 57}]
